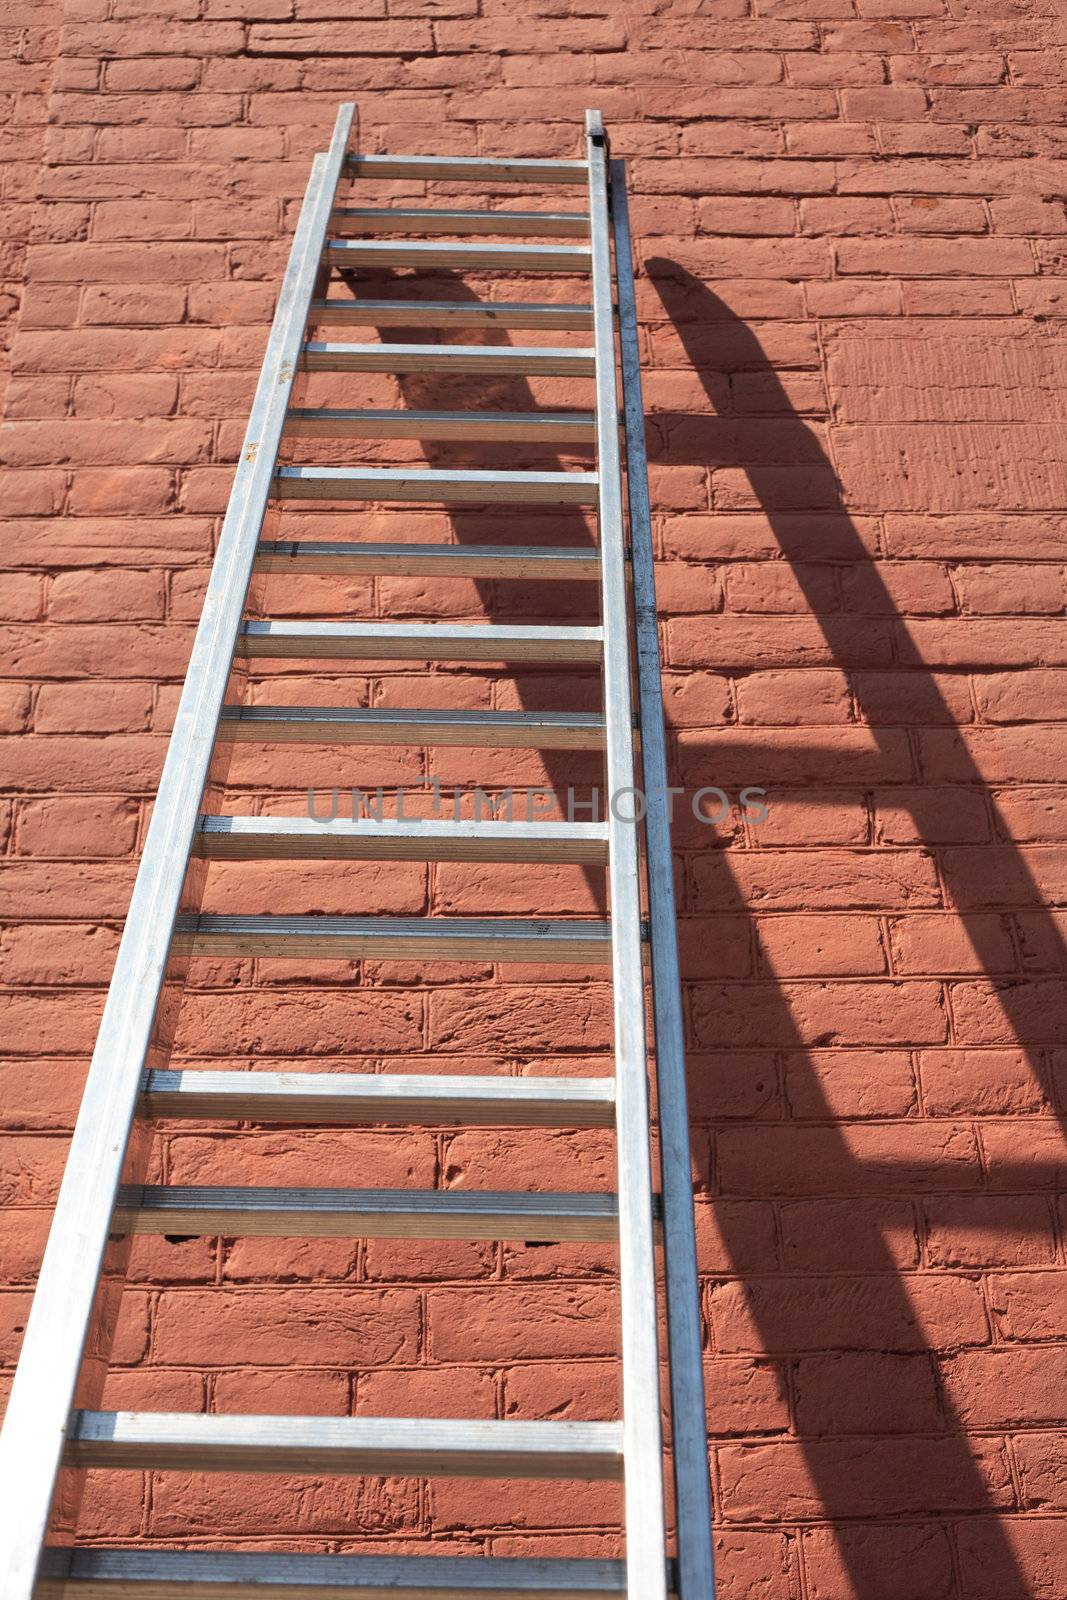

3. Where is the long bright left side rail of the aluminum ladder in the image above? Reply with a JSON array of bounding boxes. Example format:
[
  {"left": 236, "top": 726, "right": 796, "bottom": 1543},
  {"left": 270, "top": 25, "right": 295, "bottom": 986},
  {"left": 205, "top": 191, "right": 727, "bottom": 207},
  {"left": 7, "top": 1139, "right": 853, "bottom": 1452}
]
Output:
[{"left": 0, "top": 104, "right": 355, "bottom": 1600}]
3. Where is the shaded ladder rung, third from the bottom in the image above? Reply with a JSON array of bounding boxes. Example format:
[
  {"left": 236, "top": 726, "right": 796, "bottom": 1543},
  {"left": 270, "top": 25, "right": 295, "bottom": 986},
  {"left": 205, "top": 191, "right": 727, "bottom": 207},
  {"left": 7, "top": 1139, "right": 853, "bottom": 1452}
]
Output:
[{"left": 112, "top": 1184, "right": 619, "bottom": 1243}]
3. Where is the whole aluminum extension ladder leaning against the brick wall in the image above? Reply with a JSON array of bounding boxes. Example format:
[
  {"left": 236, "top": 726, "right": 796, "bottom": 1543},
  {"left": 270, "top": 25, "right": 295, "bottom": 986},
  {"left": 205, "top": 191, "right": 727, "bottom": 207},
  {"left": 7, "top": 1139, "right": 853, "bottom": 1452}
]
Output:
[{"left": 0, "top": 104, "right": 713, "bottom": 1600}]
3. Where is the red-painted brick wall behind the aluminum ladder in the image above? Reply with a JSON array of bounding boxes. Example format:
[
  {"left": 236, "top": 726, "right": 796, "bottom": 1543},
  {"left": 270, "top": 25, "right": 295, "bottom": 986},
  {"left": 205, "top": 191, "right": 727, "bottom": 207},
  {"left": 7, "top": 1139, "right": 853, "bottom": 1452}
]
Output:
[{"left": 0, "top": 0, "right": 1067, "bottom": 1600}]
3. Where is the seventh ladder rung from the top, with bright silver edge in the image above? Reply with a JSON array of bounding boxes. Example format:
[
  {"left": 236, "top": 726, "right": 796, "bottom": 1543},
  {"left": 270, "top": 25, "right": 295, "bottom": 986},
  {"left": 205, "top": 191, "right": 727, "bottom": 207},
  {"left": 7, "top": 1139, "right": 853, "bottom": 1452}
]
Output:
[{"left": 272, "top": 467, "right": 597, "bottom": 506}]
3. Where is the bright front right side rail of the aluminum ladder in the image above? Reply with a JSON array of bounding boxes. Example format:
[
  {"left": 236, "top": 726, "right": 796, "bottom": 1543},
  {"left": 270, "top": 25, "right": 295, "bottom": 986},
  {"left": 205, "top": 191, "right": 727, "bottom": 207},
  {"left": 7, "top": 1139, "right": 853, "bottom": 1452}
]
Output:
[{"left": 585, "top": 110, "right": 667, "bottom": 1600}]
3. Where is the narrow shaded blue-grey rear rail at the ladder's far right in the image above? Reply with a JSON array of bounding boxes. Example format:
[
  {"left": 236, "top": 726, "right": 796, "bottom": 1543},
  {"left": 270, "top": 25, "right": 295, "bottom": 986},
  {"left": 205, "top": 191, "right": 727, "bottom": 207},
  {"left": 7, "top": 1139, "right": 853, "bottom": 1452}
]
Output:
[{"left": 611, "top": 162, "right": 715, "bottom": 1600}]
